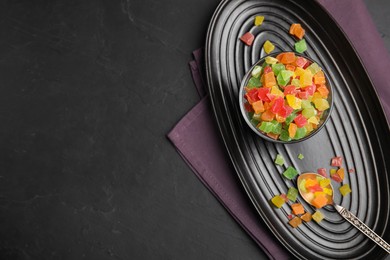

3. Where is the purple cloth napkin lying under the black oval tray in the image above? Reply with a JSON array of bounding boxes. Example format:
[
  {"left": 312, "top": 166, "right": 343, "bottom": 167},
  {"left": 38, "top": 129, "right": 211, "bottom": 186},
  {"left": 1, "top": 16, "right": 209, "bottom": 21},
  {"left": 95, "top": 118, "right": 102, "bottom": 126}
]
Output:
[{"left": 168, "top": 0, "right": 390, "bottom": 259}]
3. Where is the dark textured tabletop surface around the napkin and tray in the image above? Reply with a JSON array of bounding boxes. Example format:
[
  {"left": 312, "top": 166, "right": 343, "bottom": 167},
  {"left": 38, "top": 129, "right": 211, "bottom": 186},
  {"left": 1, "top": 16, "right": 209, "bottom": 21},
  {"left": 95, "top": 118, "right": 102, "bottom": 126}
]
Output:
[{"left": 0, "top": 0, "right": 390, "bottom": 259}]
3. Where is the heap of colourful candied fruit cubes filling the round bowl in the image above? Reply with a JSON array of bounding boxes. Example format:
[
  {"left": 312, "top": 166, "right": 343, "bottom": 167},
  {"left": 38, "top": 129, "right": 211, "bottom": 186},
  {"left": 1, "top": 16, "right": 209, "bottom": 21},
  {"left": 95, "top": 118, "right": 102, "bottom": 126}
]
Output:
[{"left": 240, "top": 52, "right": 332, "bottom": 142}]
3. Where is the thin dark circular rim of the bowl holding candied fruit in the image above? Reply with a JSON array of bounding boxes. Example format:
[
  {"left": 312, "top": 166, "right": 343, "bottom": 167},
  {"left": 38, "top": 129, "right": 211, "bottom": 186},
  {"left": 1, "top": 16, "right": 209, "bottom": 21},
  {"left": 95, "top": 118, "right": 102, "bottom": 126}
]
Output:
[{"left": 239, "top": 51, "right": 334, "bottom": 144}]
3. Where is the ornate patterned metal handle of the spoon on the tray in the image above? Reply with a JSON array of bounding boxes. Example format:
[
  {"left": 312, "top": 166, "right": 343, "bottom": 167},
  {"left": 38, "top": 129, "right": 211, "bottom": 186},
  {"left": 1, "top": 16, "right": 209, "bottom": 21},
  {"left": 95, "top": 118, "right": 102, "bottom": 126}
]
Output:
[{"left": 335, "top": 205, "right": 390, "bottom": 254}]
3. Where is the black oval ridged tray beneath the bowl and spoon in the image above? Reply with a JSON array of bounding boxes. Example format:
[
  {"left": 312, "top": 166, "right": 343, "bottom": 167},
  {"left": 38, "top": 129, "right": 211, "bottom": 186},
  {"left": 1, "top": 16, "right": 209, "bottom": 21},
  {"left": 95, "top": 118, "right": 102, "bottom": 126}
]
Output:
[{"left": 206, "top": 0, "right": 390, "bottom": 259}]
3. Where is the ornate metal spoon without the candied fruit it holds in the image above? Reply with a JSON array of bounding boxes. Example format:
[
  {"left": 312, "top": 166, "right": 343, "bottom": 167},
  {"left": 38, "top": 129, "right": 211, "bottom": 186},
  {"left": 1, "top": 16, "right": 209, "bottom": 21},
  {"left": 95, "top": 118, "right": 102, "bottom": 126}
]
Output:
[{"left": 298, "top": 173, "right": 390, "bottom": 254}]
